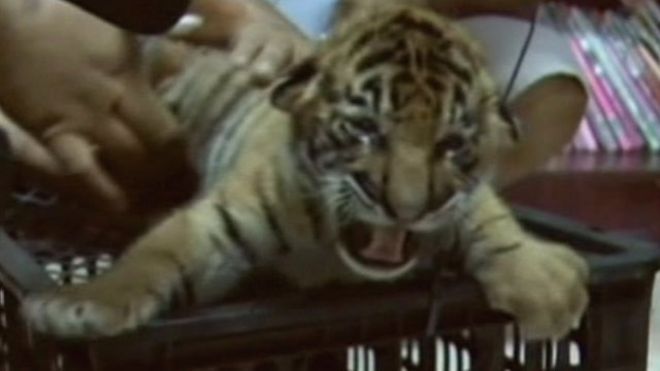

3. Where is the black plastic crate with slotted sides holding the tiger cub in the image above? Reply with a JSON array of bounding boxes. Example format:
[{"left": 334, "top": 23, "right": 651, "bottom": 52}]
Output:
[{"left": 0, "top": 195, "right": 660, "bottom": 371}]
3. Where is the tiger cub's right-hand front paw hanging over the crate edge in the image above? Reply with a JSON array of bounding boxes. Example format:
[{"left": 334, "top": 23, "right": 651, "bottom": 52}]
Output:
[{"left": 474, "top": 238, "right": 588, "bottom": 339}]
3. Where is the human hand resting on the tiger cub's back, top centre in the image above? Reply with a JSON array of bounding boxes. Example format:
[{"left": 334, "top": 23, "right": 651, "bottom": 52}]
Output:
[{"left": 170, "top": 0, "right": 311, "bottom": 83}]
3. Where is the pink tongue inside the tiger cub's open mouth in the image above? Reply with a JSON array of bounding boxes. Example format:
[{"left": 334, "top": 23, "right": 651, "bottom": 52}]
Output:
[{"left": 360, "top": 227, "right": 406, "bottom": 264}]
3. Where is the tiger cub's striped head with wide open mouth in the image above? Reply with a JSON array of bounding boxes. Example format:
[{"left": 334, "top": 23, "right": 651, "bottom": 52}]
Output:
[{"left": 272, "top": 7, "right": 515, "bottom": 279}]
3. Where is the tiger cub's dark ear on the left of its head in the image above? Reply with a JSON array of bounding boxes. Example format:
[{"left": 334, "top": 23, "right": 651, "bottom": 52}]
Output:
[{"left": 270, "top": 58, "right": 318, "bottom": 112}]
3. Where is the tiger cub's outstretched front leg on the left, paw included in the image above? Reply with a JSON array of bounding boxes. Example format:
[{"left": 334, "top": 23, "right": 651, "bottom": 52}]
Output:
[{"left": 23, "top": 201, "right": 254, "bottom": 337}]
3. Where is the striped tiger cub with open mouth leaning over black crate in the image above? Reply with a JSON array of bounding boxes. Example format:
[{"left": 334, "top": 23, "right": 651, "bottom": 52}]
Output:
[{"left": 23, "top": 6, "right": 588, "bottom": 338}]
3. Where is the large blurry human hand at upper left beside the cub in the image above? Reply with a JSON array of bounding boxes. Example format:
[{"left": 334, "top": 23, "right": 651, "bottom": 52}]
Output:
[{"left": 0, "top": 0, "right": 196, "bottom": 211}]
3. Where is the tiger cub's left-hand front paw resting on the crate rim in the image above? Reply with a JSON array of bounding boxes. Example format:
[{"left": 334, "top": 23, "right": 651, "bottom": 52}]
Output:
[{"left": 22, "top": 282, "right": 167, "bottom": 338}]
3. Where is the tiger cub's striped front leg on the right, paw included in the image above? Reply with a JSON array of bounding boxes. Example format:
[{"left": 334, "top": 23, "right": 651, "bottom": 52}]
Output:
[{"left": 461, "top": 186, "right": 588, "bottom": 339}]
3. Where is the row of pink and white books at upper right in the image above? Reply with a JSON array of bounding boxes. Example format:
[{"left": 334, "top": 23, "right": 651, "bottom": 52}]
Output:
[{"left": 539, "top": 0, "right": 660, "bottom": 153}]
